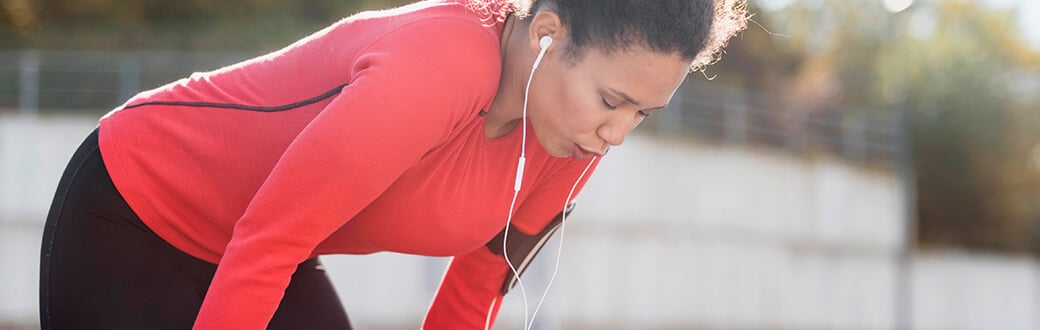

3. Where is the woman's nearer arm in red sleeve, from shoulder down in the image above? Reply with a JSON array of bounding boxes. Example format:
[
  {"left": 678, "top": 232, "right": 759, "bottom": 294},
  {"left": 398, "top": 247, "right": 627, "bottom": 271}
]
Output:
[{"left": 196, "top": 19, "right": 499, "bottom": 329}]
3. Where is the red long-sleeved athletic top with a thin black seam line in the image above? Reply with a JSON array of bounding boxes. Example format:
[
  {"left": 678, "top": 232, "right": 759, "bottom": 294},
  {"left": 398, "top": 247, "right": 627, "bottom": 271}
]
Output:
[{"left": 100, "top": 0, "right": 603, "bottom": 329}]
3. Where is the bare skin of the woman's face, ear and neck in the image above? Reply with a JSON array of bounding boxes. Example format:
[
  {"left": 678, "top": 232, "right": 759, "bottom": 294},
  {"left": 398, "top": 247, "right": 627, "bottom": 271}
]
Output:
[{"left": 485, "top": 10, "right": 691, "bottom": 159}]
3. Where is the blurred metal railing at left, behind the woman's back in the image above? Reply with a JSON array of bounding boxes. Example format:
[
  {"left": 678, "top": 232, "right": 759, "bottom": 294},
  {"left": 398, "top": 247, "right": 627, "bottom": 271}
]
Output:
[{"left": 0, "top": 51, "right": 257, "bottom": 112}]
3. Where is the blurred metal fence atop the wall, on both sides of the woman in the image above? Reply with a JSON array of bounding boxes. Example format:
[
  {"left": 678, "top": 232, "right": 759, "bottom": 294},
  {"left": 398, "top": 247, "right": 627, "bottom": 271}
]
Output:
[{"left": 0, "top": 51, "right": 906, "bottom": 167}]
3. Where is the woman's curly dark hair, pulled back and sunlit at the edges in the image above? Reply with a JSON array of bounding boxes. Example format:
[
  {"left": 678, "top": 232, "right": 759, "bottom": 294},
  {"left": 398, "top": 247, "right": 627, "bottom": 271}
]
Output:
[{"left": 474, "top": 0, "right": 749, "bottom": 71}]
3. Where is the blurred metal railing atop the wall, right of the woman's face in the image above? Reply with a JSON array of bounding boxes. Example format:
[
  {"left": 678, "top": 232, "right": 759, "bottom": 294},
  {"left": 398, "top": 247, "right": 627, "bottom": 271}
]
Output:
[{"left": 647, "top": 80, "right": 905, "bottom": 168}]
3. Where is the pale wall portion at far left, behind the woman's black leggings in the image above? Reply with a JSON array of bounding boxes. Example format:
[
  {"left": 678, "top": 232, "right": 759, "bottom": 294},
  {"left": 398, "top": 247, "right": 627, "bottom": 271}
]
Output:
[{"left": 0, "top": 116, "right": 96, "bottom": 328}]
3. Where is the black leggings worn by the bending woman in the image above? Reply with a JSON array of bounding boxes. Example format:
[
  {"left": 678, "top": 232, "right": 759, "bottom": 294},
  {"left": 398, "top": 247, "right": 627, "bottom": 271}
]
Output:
[{"left": 40, "top": 130, "right": 350, "bottom": 329}]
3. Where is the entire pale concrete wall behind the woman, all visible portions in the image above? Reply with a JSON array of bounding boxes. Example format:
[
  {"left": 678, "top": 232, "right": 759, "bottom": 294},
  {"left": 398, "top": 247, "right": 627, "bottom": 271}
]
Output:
[{"left": 0, "top": 116, "right": 1040, "bottom": 329}]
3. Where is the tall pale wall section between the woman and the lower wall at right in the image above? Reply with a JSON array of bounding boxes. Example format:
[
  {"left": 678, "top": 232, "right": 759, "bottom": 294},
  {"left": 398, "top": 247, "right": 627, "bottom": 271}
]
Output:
[{"left": 540, "top": 133, "right": 902, "bottom": 329}]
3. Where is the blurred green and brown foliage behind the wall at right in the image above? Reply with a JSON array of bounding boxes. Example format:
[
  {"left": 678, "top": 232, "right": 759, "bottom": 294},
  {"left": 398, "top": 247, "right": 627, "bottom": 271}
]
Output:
[{"left": 728, "top": 0, "right": 1040, "bottom": 254}]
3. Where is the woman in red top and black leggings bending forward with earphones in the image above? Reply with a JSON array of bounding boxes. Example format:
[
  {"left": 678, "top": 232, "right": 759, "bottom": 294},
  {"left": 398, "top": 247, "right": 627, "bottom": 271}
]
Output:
[{"left": 41, "top": 0, "right": 746, "bottom": 329}]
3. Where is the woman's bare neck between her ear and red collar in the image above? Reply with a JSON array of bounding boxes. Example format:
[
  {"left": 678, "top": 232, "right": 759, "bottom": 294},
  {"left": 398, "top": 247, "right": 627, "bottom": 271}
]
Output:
[{"left": 484, "top": 15, "right": 525, "bottom": 138}]
